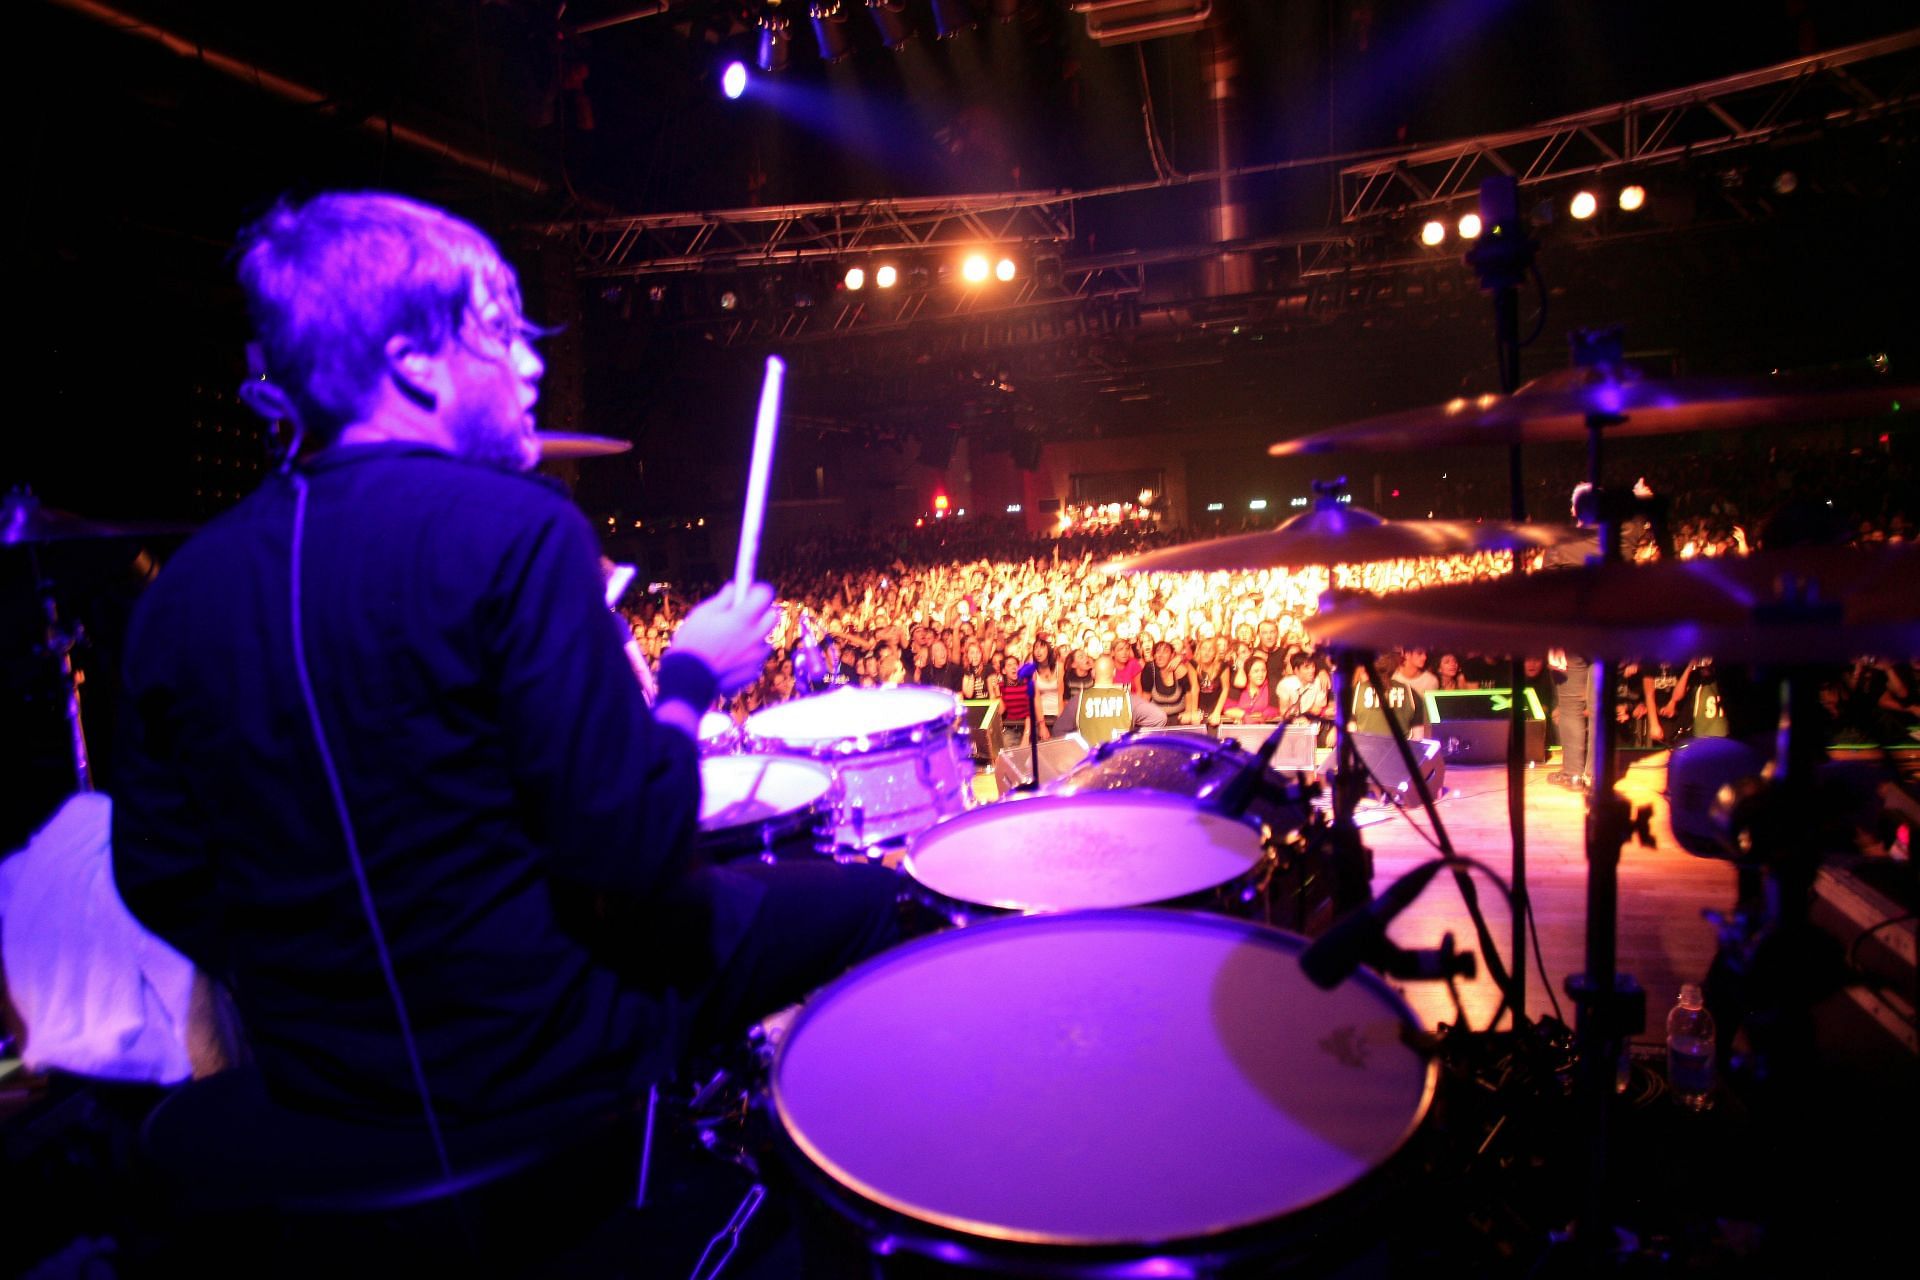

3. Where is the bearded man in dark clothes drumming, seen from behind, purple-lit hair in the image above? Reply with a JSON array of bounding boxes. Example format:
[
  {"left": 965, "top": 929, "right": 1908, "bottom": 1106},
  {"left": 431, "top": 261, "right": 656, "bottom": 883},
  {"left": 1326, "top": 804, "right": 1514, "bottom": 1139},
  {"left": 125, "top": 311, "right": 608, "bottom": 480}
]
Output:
[{"left": 113, "top": 194, "right": 895, "bottom": 1144}]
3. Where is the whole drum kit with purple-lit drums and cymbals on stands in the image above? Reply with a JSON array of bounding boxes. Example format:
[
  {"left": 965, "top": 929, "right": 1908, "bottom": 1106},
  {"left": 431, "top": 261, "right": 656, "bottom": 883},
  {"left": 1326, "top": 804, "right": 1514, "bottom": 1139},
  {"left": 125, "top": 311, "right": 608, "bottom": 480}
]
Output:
[{"left": 672, "top": 343, "right": 1920, "bottom": 1276}]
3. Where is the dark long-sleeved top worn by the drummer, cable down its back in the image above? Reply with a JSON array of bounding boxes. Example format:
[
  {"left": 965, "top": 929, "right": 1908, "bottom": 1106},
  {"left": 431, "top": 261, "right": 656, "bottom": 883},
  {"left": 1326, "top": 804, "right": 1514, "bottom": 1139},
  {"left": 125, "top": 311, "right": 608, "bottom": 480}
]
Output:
[{"left": 113, "top": 445, "right": 702, "bottom": 1126}]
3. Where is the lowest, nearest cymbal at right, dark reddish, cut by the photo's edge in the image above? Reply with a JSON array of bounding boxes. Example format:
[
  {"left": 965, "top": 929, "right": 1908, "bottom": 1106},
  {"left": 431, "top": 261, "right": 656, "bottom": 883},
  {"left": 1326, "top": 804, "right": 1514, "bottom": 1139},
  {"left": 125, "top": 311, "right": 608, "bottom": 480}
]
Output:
[{"left": 1306, "top": 545, "right": 1920, "bottom": 662}]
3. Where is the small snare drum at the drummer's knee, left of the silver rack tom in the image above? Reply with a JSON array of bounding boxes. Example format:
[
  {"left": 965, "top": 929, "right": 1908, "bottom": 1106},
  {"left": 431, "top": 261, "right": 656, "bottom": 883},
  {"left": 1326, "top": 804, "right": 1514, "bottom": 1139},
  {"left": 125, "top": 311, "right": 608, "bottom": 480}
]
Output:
[{"left": 695, "top": 756, "right": 839, "bottom": 862}]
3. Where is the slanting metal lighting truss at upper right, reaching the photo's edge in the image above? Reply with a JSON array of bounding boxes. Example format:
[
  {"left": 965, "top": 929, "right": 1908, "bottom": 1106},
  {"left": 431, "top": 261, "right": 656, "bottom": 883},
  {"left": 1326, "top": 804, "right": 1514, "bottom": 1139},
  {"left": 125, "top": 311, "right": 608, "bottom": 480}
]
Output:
[{"left": 1340, "top": 29, "right": 1920, "bottom": 223}]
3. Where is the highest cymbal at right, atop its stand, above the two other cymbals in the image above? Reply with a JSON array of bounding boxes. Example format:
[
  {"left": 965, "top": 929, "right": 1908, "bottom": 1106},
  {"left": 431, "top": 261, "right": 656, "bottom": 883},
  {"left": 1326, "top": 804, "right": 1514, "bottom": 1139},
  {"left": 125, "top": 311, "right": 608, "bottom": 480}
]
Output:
[{"left": 1267, "top": 365, "right": 1920, "bottom": 459}]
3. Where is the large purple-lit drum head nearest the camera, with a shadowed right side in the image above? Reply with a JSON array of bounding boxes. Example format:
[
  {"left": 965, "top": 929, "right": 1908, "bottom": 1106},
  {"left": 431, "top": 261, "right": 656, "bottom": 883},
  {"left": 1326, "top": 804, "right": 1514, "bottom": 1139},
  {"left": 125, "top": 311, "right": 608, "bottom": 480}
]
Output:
[{"left": 774, "top": 912, "right": 1436, "bottom": 1247}]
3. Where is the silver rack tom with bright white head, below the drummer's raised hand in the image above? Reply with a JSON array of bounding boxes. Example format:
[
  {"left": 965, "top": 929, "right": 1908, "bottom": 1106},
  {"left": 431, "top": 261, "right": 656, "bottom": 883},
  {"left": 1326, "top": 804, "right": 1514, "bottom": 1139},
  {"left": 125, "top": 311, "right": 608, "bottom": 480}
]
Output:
[{"left": 743, "top": 685, "right": 973, "bottom": 850}]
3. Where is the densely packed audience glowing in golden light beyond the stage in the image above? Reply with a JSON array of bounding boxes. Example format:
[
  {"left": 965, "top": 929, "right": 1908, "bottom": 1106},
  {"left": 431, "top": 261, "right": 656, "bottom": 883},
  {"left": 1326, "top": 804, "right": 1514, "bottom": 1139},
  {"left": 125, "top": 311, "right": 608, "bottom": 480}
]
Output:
[{"left": 624, "top": 435, "right": 1920, "bottom": 747}]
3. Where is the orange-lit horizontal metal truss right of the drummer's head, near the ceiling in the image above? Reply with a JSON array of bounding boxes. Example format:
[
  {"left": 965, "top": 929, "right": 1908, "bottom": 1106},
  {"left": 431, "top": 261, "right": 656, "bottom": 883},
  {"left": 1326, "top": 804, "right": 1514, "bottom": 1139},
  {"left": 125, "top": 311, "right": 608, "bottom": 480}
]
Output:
[{"left": 547, "top": 192, "right": 1073, "bottom": 278}]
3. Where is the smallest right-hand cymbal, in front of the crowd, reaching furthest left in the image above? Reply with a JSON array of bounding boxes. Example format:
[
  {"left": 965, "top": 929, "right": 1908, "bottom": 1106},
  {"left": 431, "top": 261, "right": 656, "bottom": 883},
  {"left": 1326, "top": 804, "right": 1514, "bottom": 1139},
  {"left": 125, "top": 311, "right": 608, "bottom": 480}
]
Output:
[{"left": 1104, "top": 501, "right": 1586, "bottom": 574}]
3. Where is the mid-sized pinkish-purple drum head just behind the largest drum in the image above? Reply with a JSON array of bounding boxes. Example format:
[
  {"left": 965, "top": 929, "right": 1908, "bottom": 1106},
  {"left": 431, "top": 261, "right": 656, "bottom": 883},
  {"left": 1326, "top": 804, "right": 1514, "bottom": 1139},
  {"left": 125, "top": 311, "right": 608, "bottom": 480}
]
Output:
[{"left": 904, "top": 791, "right": 1265, "bottom": 912}]
